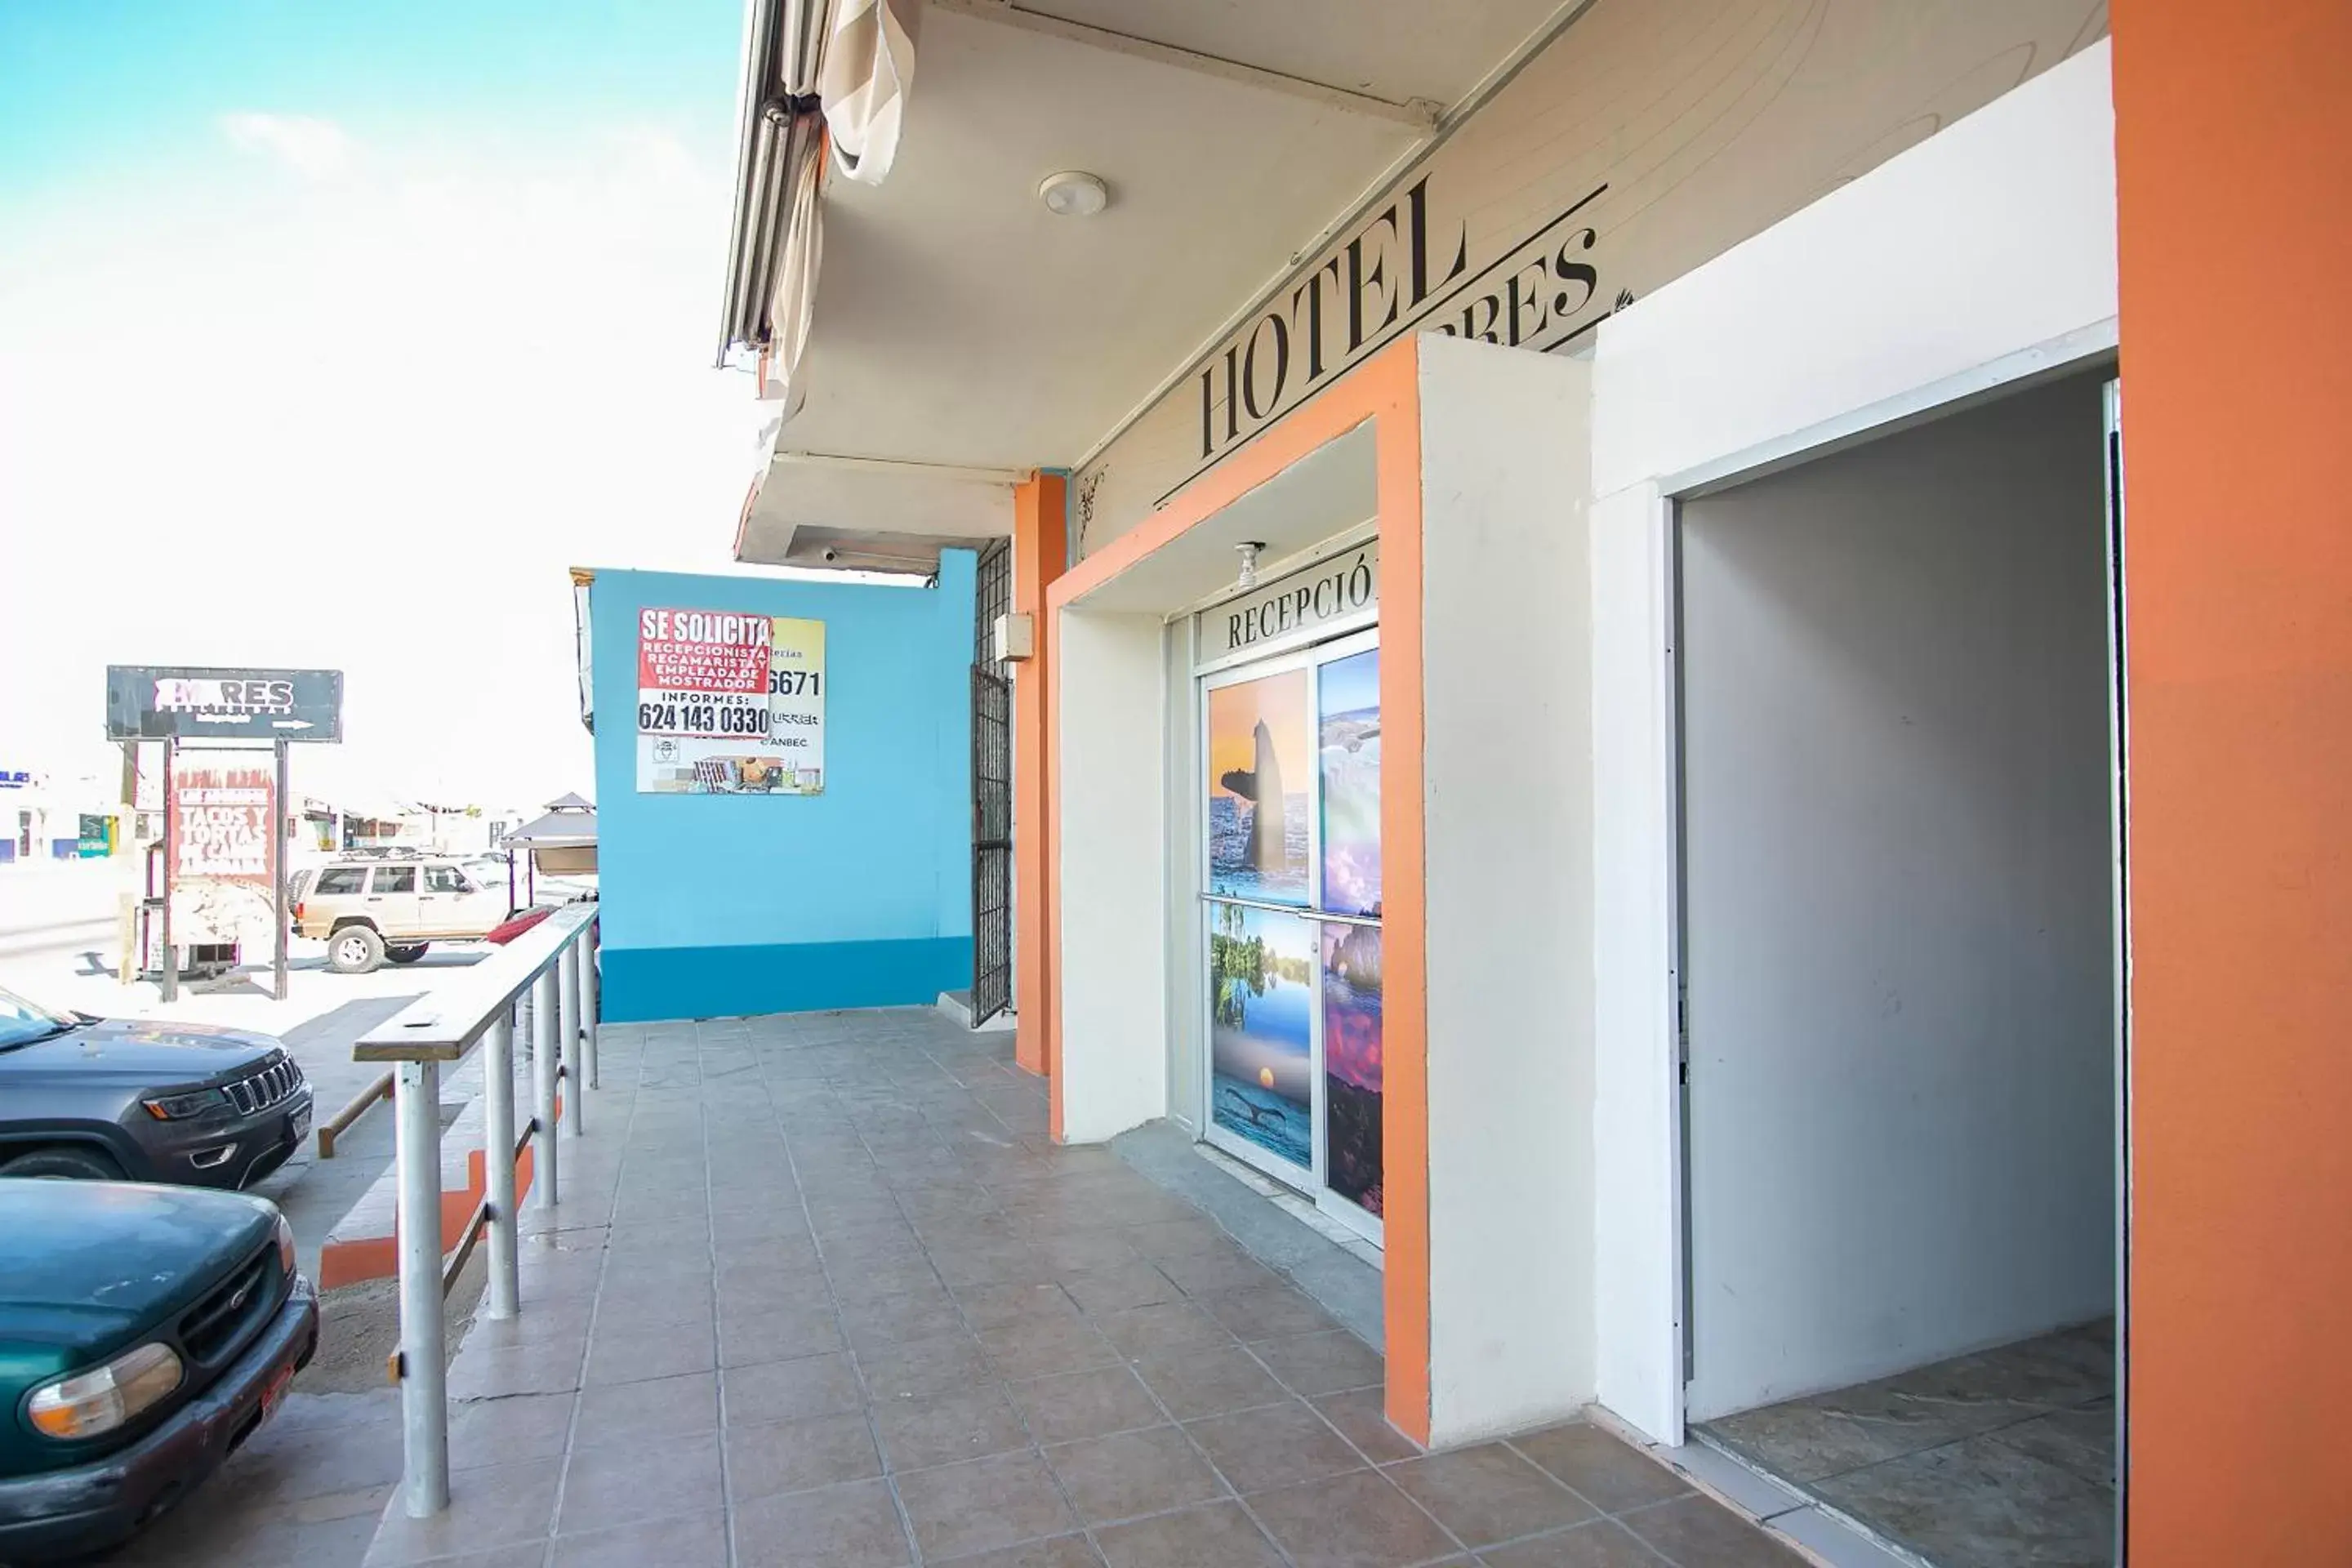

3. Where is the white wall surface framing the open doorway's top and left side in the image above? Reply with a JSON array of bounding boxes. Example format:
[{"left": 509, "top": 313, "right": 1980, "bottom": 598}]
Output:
[{"left": 1590, "top": 42, "right": 2114, "bottom": 1441}]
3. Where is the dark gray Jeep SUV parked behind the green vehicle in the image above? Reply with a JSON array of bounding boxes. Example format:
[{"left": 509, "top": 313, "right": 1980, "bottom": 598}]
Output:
[{"left": 0, "top": 990, "right": 310, "bottom": 1190}]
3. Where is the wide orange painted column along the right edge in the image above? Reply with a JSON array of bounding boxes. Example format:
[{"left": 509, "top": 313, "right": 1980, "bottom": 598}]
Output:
[{"left": 2114, "top": 0, "right": 2352, "bottom": 1568}]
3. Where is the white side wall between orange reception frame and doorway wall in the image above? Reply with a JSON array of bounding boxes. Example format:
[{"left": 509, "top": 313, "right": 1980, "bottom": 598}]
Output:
[{"left": 1421, "top": 336, "right": 1592, "bottom": 1446}]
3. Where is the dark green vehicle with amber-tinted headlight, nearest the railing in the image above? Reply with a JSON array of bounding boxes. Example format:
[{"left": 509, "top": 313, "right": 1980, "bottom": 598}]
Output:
[{"left": 0, "top": 1178, "right": 318, "bottom": 1568}]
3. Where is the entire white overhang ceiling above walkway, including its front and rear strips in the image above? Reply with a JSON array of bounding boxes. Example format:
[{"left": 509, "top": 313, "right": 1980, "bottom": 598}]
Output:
[{"left": 738, "top": 0, "right": 1559, "bottom": 562}]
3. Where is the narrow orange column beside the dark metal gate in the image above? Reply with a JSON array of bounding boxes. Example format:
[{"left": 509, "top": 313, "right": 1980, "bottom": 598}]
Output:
[{"left": 1013, "top": 473, "right": 1070, "bottom": 1072}]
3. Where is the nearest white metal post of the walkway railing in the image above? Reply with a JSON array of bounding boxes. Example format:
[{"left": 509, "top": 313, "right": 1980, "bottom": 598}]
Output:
[{"left": 393, "top": 1062, "right": 449, "bottom": 1519}]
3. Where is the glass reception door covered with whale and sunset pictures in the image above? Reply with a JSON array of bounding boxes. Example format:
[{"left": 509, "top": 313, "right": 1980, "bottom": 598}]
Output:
[{"left": 1202, "top": 632, "right": 1383, "bottom": 1236}]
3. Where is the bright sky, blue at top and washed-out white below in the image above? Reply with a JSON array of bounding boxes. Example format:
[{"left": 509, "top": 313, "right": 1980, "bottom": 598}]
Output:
[{"left": 0, "top": 0, "right": 785, "bottom": 806}]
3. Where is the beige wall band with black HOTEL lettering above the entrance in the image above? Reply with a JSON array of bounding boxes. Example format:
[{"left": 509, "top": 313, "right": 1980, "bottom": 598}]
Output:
[{"left": 1075, "top": 0, "right": 2105, "bottom": 555}]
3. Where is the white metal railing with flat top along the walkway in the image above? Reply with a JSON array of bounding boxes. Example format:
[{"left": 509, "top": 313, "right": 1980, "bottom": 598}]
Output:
[{"left": 350, "top": 902, "right": 598, "bottom": 1519}]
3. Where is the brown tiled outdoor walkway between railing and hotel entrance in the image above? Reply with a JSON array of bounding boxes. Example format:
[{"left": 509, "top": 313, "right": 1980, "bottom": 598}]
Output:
[{"left": 367, "top": 1011, "right": 1799, "bottom": 1568}]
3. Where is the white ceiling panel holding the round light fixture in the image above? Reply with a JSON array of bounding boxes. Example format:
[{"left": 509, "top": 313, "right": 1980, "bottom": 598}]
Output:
[{"left": 778, "top": 10, "right": 1411, "bottom": 468}]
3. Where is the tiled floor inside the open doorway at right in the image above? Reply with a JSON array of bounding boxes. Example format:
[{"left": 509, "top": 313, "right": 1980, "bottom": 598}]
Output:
[{"left": 1703, "top": 1319, "right": 2114, "bottom": 1568}]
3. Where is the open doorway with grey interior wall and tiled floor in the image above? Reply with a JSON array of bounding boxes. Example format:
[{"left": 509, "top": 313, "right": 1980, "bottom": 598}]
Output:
[{"left": 1675, "top": 372, "right": 2127, "bottom": 1568}]
